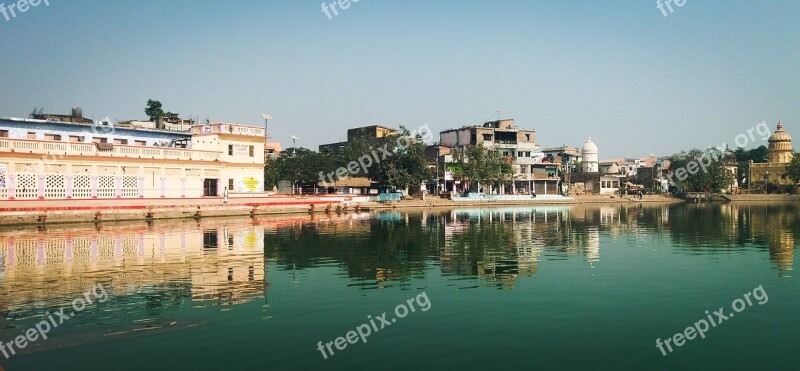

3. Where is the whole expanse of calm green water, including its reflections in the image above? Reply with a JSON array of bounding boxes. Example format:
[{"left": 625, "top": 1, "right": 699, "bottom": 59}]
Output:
[{"left": 0, "top": 204, "right": 800, "bottom": 371}]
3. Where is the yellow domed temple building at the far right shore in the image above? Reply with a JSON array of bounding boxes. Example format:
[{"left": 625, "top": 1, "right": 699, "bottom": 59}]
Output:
[{"left": 749, "top": 122, "right": 794, "bottom": 185}]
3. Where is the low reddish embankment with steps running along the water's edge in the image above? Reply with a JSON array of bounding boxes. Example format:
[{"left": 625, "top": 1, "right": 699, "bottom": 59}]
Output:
[{"left": 0, "top": 196, "right": 683, "bottom": 226}]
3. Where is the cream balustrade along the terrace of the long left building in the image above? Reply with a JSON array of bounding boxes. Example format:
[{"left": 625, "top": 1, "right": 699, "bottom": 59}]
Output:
[{"left": 0, "top": 138, "right": 220, "bottom": 161}]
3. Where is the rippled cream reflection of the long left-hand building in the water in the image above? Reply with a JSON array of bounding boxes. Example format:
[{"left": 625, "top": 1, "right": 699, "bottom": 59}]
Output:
[{"left": 0, "top": 219, "right": 266, "bottom": 311}]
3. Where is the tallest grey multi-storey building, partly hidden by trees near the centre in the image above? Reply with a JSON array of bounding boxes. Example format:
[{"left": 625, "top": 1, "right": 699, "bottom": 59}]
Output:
[{"left": 439, "top": 119, "right": 560, "bottom": 194}]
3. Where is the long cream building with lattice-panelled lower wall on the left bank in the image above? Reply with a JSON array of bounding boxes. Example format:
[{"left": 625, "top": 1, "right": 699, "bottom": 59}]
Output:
[{"left": 0, "top": 114, "right": 264, "bottom": 200}]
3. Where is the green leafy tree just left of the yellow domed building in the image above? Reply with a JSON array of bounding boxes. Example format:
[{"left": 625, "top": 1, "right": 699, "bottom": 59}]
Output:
[{"left": 669, "top": 149, "right": 733, "bottom": 192}]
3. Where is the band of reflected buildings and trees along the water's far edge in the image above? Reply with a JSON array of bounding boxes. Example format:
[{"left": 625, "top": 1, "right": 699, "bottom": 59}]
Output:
[{"left": 0, "top": 203, "right": 800, "bottom": 328}]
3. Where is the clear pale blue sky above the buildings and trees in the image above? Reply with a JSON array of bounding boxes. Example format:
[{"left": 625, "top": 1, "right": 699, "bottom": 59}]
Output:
[{"left": 0, "top": 0, "right": 800, "bottom": 159}]
